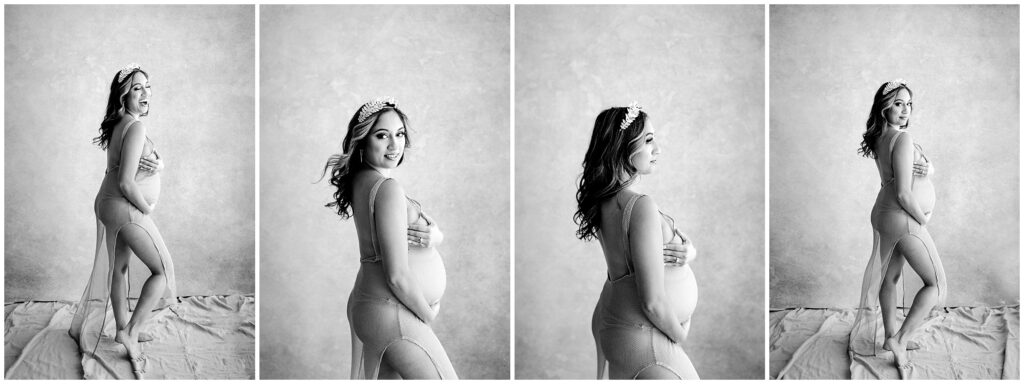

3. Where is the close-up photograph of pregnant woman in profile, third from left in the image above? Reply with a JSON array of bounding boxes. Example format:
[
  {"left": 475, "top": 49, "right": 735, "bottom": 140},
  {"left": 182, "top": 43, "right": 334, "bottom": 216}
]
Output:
[{"left": 515, "top": 5, "right": 765, "bottom": 380}]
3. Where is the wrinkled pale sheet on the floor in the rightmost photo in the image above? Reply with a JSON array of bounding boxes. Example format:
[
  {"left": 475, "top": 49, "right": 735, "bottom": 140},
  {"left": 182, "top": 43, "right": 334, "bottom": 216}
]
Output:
[{"left": 769, "top": 305, "right": 1020, "bottom": 380}]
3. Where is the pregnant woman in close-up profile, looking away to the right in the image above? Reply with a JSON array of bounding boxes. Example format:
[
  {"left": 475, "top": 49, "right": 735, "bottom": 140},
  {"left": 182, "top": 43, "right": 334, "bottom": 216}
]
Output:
[{"left": 574, "top": 102, "right": 699, "bottom": 380}]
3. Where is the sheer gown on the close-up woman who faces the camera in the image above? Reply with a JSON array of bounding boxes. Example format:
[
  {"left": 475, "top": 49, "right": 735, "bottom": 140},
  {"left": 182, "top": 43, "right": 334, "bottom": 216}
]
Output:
[{"left": 348, "top": 177, "right": 459, "bottom": 380}]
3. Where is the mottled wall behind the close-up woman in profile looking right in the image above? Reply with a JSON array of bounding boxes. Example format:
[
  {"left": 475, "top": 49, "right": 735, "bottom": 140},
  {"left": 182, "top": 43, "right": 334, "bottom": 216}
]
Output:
[{"left": 515, "top": 5, "right": 765, "bottom": 379}]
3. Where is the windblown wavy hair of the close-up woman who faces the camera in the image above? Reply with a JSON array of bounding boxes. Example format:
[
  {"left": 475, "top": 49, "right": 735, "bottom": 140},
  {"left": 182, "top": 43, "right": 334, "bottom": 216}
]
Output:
[{"left": 321, "top": 100, "right": 413, "bottom": 219}]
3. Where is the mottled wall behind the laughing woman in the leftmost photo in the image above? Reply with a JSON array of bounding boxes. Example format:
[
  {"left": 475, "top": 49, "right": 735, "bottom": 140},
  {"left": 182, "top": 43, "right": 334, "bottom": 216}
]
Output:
[{"left": 4, "top": 5, "right": 256, "bottom": 302}]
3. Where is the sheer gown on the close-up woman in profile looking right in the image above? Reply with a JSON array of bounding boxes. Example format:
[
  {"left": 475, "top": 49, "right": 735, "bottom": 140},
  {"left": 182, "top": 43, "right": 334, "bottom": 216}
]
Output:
[{"left": 591, "top": 195, "right": 699, "bottom": 380}]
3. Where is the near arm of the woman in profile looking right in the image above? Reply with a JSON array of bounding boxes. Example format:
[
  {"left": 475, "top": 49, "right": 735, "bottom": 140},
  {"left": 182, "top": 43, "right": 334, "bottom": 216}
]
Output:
[{"left": 629, "top": 197, "right": 686, "bottom": 343}]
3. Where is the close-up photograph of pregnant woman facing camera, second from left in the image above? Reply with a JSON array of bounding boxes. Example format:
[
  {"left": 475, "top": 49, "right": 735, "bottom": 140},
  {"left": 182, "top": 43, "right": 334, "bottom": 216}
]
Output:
[{"left": 259, "top": 5, "right": 512, "bottom": 380}]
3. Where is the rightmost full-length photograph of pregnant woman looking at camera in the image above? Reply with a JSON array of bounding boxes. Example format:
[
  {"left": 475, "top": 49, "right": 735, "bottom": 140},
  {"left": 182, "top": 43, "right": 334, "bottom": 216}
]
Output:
[{"left": 769, "top": 5, "right": 1020, "bottom": 380}]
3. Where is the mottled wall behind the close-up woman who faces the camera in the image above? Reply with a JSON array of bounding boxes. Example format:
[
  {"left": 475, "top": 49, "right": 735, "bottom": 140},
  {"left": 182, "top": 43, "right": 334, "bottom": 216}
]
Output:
[{"left": 260, "top": 5, "right": 510, "bottom": 379}]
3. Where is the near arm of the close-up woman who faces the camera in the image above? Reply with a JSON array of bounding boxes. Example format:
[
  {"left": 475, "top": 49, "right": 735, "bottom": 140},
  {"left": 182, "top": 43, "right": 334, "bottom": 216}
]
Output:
[{"left": 378, "top": 180, "right": 436, "bottom": 324}]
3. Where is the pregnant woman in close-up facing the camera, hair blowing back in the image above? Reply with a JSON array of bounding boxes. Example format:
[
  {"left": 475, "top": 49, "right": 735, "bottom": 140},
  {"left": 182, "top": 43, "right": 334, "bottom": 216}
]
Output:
[{"left": 324, "top": 98, "right": 458, "bottom": 379}]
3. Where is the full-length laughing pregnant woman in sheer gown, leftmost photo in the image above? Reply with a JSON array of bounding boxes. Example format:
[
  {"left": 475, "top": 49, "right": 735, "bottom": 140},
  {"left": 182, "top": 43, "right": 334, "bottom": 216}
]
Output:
[{"left": 70, "top": 65, "right": 177, "bottom": 379}]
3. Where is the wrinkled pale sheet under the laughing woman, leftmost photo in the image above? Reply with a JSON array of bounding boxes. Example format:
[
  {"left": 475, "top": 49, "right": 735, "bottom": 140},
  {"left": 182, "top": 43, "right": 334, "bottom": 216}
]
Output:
[{"left": 4, "top": 295, "right": 256, "bottom": 380}]
